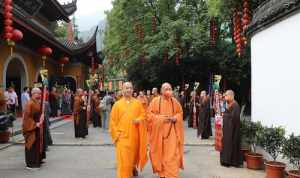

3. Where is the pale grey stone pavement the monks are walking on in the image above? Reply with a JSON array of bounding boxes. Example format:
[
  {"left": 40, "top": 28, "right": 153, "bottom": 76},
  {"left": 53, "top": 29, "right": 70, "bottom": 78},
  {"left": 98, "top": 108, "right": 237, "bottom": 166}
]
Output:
[{"left": 0, "top": 121, "right": 265, "bottom": 178}]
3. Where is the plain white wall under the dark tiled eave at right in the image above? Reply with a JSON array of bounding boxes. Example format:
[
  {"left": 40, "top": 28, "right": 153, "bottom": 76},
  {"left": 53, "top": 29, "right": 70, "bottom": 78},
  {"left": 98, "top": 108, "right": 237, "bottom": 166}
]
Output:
[{"left": 251, "top": 13, "right": 300, "bottom": 135}]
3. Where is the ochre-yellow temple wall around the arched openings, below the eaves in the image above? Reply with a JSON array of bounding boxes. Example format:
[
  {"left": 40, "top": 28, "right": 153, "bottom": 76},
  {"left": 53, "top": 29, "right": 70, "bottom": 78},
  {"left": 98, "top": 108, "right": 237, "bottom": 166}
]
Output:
[{"left": 0, "top": 44, "right": 86, "bottom": 87}]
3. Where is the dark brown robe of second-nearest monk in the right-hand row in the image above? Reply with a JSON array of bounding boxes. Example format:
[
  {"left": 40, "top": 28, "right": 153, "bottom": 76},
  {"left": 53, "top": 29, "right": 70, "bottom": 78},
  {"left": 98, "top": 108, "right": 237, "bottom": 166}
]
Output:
[{"left": 197, "top": 98, "right": 212, "bottom": 139}]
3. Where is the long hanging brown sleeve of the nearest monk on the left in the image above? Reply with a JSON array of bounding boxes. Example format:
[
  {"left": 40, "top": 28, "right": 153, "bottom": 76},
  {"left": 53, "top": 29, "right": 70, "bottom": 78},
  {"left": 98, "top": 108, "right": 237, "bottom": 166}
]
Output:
[{"left": 22, "top": 101, "right": 36, "bottom": 149}]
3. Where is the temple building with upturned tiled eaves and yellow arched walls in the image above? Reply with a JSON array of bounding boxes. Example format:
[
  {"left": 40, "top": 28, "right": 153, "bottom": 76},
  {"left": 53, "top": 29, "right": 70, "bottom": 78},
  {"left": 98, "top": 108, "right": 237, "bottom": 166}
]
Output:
[{"left": 0, "top": 0, "right": 101, "bottom": 97}]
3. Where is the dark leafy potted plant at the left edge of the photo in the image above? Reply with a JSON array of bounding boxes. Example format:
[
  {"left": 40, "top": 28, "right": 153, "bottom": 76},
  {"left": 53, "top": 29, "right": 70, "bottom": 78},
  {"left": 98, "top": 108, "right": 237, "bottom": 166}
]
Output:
[{"left": 0, "top": 113, "right": 15, "bottom": 143}]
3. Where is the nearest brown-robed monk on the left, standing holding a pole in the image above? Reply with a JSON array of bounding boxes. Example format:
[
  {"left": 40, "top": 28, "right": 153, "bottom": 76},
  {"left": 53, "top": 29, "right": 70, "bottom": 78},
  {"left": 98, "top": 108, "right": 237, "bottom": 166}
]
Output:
[{"left": 22, "top": 88, "right": 46, "bottom": 169}]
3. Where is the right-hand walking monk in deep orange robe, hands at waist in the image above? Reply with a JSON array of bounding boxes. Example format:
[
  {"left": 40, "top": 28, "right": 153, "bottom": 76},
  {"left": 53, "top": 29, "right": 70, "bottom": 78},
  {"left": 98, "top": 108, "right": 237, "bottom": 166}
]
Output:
[{"left": 147, "top": 83, "right": 184, "bottom": 178}]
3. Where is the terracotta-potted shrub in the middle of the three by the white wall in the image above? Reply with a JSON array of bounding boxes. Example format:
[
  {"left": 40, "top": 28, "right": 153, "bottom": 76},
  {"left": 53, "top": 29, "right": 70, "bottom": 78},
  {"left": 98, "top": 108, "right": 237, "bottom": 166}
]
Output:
[{"left": 260, "top": 127, "right": 286, "bottom": 178}]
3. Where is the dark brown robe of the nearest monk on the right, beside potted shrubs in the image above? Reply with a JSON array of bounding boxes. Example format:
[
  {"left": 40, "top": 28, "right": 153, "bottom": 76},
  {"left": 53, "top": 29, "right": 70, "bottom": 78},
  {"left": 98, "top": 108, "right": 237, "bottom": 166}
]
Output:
[{"left": 220, "top": 101, "right": 242, "bottom": 167}]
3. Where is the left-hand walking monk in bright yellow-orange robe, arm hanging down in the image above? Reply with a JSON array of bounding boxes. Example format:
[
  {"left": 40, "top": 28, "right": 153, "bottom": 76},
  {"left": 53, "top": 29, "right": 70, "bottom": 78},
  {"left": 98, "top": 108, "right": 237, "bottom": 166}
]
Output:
[{"left": 109, "top": 82, "right": 147, "bottom": 178}]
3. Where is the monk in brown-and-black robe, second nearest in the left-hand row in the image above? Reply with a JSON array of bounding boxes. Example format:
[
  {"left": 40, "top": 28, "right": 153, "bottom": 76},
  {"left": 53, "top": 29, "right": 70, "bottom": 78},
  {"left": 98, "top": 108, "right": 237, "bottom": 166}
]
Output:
[{"left": 73, "top": 88, "right": 88, "bottom": 138}]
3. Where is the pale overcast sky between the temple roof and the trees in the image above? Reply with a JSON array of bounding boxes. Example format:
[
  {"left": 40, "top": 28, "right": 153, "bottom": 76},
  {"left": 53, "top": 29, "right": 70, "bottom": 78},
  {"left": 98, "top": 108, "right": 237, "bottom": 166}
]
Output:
[{"left": 58, "top": 0, "right": 112, "bottom": 31}]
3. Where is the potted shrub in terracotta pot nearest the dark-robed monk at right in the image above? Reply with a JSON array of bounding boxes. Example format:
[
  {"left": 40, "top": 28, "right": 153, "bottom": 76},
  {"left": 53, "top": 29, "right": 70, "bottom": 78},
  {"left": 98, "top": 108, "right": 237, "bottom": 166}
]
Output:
[{"left": 244, "top": 121, "right": 263, "bottom": 170}]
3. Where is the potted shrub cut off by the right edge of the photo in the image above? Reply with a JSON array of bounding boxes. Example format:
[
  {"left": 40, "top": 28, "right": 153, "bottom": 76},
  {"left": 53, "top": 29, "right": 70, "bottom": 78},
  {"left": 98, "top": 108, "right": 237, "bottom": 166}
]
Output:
[{"left": 282, "top": 134, "right": 300, "bottom": 178}]
